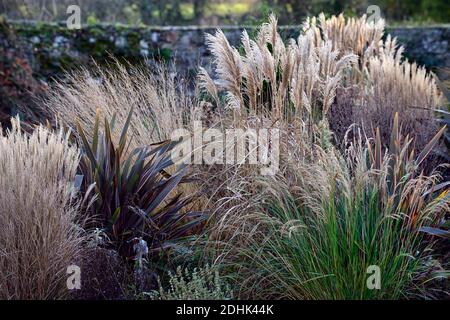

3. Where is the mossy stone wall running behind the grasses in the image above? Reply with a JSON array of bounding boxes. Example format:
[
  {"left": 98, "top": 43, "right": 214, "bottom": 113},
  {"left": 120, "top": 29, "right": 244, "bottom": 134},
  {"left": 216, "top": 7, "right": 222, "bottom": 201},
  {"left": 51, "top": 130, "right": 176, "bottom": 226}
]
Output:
[{"left": 0, "top": 22, "right": 450, "bottom": 78}]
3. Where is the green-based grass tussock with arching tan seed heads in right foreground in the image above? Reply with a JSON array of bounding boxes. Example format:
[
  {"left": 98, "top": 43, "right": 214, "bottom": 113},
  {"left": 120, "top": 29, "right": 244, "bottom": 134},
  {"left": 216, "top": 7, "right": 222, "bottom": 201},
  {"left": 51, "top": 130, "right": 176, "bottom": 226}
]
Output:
[{"left": 212, "top": 116, "right": 450, "bottom": 299}]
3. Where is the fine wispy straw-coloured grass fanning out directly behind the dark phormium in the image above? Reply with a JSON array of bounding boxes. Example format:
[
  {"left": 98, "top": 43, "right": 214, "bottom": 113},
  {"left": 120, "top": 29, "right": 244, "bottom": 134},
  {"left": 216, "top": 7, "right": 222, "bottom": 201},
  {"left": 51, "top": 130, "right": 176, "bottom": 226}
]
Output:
[{"left": 44, "top": 62, "right": 193, "bottom": 149}]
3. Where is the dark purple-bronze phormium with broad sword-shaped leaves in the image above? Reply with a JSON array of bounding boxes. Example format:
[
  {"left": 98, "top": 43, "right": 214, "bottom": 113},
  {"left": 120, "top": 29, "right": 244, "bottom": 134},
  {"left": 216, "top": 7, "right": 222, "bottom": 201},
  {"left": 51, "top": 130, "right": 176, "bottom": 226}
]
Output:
[{"left": 78, "top": 110, "right": 205, "bottom": 258}]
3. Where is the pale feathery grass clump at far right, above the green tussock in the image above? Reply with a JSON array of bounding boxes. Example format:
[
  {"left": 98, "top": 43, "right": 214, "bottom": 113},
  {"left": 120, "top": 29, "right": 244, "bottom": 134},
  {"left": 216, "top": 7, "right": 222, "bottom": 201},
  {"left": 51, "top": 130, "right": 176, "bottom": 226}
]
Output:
[{"left": 354, "top": 54, "right": 442, "bottom": 166}]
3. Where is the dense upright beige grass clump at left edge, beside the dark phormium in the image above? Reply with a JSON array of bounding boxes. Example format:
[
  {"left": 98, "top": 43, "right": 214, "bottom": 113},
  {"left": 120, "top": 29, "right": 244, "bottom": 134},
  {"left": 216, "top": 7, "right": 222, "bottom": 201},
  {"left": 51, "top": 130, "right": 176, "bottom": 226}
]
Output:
[{"left": 0, "top": 120, "right": 83, "bottom": 299}]
